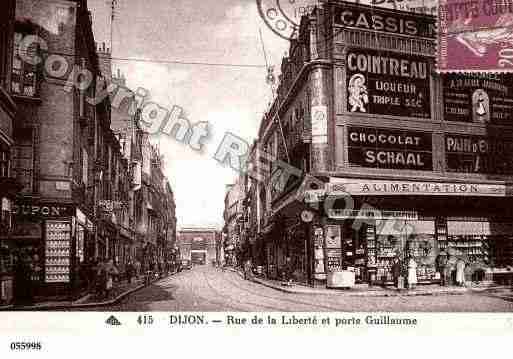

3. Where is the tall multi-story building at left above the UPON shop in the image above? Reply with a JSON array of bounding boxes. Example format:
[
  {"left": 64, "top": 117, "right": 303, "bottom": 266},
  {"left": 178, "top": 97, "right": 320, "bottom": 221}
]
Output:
[{"left": 4, "top": 0, "right": 110, "bottom": 296}]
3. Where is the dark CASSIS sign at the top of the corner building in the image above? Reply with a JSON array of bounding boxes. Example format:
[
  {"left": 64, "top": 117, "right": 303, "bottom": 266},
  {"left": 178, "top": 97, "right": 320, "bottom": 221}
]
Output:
[{"left": 334, "top": 4, "right": 436, "bottom": 39}]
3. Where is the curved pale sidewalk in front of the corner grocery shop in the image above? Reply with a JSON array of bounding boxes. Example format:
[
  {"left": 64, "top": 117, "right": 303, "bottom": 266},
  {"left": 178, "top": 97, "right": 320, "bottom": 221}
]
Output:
[{"left": 230, "top": 268, "right": 472, "bottom": 297}]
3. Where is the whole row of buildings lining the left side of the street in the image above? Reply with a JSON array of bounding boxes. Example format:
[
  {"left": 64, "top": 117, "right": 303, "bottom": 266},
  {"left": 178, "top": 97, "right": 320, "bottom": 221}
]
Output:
[{"left": 0, "top": 0, "right": 176, "bottom": 300}]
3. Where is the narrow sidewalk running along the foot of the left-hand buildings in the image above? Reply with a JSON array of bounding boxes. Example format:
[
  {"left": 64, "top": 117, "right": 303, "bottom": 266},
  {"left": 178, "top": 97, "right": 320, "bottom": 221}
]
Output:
[{"left": 0, "top": 272, "right": 176, "bottom": 311}]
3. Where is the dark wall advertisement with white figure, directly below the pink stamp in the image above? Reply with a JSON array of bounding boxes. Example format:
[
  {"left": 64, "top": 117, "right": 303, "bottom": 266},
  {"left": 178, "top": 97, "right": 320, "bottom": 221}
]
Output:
[{"left": 442, "top": 73, "right": 513, "bottom": 125}]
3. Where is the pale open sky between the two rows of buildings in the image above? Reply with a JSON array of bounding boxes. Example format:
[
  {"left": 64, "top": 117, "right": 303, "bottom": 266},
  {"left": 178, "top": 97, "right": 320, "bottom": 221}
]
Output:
[{"left": 88, "top": 0, "right": 289, "bottom": 228}]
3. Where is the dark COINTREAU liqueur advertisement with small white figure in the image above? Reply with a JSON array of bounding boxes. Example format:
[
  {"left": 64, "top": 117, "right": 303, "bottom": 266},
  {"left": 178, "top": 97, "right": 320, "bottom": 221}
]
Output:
[{"left": 346, "top": 49, "right": 431, "bottom": 118}]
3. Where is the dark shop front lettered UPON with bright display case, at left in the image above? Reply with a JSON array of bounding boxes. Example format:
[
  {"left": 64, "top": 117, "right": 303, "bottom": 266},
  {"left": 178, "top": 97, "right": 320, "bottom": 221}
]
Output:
[{"left": 8, "top": 202, "right": 76, "bottom": 301}]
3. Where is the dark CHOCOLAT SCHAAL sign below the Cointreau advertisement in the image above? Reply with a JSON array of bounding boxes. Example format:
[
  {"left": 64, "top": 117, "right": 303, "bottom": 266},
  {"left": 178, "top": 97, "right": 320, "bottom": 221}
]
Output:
[{"left": 348, "top": 127, "right": 433, "bottom": 171}]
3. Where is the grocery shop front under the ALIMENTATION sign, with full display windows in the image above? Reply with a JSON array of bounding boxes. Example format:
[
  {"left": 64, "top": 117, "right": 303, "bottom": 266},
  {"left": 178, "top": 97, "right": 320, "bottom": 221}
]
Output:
[{"left": 302, "top": 178, "right": 513, "bottom": 285}]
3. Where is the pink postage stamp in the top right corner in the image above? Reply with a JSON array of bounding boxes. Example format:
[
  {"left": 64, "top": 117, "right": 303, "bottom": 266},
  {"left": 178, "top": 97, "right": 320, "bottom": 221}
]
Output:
[{"left": 437, "top": 0, "right": 513, "bottom": 72}]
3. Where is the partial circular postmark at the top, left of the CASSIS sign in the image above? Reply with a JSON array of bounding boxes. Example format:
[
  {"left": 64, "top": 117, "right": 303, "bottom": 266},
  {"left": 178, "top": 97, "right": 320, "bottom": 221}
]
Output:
[{"left": 256, "top": 0, "right": 319, "bottom": 40}]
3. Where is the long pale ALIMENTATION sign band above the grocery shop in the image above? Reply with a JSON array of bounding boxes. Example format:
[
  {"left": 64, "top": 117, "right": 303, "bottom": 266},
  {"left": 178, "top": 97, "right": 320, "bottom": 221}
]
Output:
[{"left": 326, "top": 178, "right": 511, "bottom": 197}]
